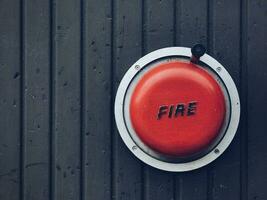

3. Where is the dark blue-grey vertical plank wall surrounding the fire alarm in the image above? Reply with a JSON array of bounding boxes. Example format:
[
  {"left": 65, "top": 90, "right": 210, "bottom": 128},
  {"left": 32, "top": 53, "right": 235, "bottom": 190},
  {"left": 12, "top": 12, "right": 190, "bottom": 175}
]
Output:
[{"left": 0, "top": 0, "right": 267, "bottom": 200}]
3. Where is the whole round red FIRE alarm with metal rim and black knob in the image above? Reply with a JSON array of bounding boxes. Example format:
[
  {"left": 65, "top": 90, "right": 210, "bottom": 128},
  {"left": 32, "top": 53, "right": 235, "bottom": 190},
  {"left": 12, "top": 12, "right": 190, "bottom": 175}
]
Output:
[{"left": 115, "top": 44, "right": 240, "bottom": 172}]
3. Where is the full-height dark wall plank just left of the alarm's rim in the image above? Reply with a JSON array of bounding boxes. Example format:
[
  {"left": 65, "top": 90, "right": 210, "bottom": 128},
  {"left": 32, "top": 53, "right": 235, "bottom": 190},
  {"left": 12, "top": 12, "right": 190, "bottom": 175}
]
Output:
[{"left": 83, "top": 0, "right": 113, "bottom": 200}]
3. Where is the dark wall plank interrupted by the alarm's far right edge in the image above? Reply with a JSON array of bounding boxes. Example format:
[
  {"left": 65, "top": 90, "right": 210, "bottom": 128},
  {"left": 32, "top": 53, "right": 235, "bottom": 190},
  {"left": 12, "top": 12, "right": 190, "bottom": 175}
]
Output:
[{"left": 209, "top": 0, "right": 241, "bottom": 200}]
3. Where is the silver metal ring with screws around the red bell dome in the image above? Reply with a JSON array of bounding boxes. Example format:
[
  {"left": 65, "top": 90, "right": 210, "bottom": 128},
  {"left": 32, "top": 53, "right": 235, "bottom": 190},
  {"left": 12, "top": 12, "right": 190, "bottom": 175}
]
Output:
[{"left": 115, "top": 47, "right": 240, "bottom": 172}]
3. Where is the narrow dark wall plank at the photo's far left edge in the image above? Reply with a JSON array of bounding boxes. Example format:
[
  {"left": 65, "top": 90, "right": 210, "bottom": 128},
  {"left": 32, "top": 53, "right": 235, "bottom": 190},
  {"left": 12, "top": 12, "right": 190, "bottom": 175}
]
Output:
[{"left": 0, "top": 0, "right": 21, "bottom": 200}]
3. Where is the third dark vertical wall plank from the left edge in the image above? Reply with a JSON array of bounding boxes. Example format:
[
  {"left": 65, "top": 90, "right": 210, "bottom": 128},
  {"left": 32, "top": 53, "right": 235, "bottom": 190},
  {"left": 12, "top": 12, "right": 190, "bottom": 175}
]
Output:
[{"left": 53, "top": 0, "right": 81, "bottom": 200}]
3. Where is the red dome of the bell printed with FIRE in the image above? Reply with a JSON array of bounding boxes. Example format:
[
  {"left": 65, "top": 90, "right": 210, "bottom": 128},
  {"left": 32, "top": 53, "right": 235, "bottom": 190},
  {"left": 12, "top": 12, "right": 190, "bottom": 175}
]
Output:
[{"left": 130, "top": 61, "right": 226, "bottom": 157}]
